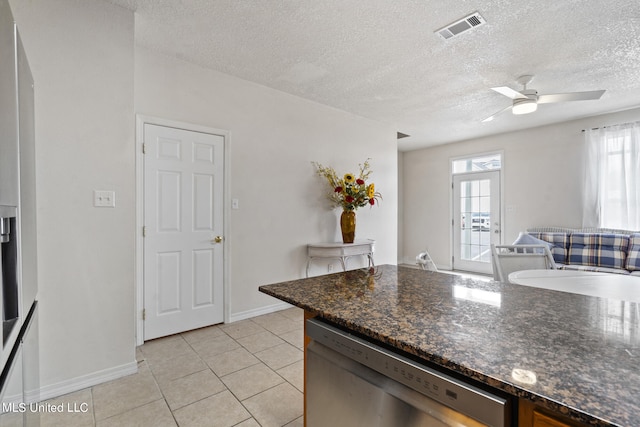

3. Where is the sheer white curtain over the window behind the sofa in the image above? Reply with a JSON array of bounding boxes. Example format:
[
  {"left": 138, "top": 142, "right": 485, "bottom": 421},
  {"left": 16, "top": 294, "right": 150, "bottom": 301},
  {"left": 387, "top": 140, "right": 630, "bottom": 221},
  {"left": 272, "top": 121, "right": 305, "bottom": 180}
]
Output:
[{"left": 582, "top": 122, "right": 640, "bottom": 230}]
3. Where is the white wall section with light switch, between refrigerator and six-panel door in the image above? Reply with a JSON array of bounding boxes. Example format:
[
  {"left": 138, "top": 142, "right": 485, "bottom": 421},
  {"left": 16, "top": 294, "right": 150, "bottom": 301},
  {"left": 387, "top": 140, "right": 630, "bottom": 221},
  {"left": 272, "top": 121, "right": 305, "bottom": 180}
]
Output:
[{"left": 10, "top": 0, "right": 136, "bottom": 397}]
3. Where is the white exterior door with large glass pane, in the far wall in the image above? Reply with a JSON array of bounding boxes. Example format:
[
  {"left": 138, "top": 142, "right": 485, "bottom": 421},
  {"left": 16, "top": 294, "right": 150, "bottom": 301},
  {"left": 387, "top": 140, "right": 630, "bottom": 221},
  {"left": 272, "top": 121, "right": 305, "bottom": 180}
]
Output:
[{"left": 452, "top": 171, "right": 501, "bottom": 274}]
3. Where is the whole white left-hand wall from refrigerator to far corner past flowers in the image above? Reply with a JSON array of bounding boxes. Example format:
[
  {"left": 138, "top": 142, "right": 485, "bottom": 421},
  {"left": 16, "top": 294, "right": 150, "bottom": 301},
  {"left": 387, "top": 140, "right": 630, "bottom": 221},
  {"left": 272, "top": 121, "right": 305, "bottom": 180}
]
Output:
[{"left": 10, "top": 0, "right": 397, "bottom": 398}]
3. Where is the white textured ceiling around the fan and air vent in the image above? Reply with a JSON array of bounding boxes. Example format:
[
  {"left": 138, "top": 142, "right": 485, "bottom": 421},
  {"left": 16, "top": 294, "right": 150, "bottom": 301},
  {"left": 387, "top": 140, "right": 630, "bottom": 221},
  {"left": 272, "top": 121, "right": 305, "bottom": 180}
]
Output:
[{"left": 106, "top": 0, "right": 640, "bottom": 150}]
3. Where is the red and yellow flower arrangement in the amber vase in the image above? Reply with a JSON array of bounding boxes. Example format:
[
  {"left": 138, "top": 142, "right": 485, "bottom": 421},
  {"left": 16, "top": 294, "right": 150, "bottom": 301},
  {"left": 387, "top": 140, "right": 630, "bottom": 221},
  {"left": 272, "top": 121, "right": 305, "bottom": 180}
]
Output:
[{"left": 311, "top": 159, "right": 382, "bottom": 211}]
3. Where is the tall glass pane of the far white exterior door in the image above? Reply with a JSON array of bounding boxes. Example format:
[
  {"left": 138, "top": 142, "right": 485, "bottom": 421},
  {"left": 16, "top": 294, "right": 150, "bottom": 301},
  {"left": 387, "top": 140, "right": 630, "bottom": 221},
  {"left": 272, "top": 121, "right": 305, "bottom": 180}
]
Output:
[{"left": 458, "top": 179, "right": 491, "bottom": 262}]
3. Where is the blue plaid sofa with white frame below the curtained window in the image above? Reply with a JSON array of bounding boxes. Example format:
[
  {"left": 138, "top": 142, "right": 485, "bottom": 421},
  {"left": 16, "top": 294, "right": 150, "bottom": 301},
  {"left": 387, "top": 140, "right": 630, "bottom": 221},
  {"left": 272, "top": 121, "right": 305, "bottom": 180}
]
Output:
[{"left": 527, "top": 227, "right": 640, "bottom": 276}]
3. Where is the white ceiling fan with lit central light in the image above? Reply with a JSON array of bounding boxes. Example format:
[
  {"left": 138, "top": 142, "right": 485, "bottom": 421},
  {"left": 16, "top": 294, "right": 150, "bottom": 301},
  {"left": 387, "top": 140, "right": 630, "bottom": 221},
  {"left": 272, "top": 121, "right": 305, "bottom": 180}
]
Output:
[{"left": 482, "top": 75, "right": 605, "bottom": 122}]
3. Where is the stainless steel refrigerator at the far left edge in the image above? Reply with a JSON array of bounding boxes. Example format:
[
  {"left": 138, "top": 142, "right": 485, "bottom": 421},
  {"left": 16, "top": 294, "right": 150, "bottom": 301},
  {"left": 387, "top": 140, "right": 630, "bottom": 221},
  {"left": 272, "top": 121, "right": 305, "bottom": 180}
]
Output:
[{"left": 0, "top": 0, "right": 40, "bottom": 426}]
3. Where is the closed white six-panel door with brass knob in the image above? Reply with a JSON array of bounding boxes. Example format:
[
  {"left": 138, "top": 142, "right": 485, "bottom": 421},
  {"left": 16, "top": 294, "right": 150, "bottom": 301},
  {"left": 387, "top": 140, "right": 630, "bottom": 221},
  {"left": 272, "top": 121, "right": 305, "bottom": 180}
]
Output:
[{"left": 144, "top": 124, "right": 224, "bottom": 340}]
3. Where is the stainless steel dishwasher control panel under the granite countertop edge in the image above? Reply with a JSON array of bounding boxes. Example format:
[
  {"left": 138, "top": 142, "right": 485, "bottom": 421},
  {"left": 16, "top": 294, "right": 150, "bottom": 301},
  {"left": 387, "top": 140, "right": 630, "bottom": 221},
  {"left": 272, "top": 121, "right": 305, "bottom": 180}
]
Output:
[{"left": 307, "top": 319, "right": 508, "bottom": 427}]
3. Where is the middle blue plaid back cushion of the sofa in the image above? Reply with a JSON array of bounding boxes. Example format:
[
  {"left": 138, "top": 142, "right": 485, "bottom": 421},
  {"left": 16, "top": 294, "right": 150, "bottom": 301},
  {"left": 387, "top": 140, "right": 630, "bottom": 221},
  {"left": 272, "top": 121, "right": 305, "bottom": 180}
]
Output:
[{"left": 567, "top": 233, "right": 629, "bottom": 268}]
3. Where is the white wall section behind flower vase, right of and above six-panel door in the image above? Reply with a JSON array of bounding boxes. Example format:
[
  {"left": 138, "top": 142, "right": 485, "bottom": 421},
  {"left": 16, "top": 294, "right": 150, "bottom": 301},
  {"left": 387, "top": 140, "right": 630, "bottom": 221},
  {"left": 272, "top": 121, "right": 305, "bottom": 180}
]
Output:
[{"left": 135, "top": 47, "right": 398, "bottom": 320}]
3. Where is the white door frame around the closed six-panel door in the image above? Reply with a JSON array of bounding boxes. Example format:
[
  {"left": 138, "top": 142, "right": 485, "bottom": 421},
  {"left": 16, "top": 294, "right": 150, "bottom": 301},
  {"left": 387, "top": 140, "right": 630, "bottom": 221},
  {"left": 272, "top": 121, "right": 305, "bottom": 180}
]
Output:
[{"left": 135, "top": 114, "right": 230, "bottom": 346}]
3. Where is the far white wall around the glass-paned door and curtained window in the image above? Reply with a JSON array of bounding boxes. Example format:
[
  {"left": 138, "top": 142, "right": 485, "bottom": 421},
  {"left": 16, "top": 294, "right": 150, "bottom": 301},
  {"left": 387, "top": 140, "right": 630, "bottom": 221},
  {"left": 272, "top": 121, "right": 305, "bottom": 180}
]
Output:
[{"left": 399, "top": 109, "right": 640, "bottom": 268}]
